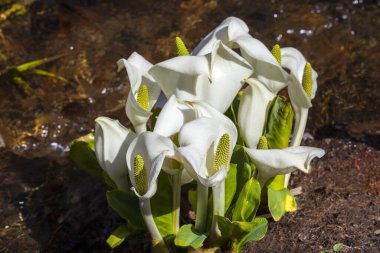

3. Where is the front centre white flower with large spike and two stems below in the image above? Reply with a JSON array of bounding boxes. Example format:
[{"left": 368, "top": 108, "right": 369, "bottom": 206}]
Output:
[{"left": 178, "top": 114, "right": 237, "bottom": 236}]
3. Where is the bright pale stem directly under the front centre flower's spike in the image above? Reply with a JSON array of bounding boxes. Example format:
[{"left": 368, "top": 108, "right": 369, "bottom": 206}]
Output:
[{"left": 211, "top": 180, "right": 225, "bottom": 239}]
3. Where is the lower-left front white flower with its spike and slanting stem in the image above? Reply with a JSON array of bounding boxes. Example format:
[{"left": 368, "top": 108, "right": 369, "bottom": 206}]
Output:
[{"left": 126, "top": 132, "right": 182, "bottom": 248}]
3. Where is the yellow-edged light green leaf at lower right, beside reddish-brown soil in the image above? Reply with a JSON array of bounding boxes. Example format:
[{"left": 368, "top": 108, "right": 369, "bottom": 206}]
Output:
[{"left": 268, "top": 188, "right": 297, "bottom": 221}]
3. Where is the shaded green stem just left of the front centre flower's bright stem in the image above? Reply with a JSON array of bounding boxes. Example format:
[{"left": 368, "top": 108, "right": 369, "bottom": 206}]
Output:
[{"left": 195, "top": 182, "right": 208, "bottom": 232}]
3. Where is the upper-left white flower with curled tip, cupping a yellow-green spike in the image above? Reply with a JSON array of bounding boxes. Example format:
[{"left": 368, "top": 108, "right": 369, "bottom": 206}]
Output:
[{"left": 117, "top": 53, "right": 161, "bottom": 134}]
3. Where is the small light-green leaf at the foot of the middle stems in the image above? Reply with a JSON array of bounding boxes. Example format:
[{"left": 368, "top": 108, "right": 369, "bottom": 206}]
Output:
[{"left": 174, "top": 224, "right": 207, "bottom": 249}]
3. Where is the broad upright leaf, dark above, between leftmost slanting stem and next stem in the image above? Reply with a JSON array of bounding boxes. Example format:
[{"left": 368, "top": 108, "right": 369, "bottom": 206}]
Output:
[{"left": 150, "top": 172, "right": 175, "bottom": 238}]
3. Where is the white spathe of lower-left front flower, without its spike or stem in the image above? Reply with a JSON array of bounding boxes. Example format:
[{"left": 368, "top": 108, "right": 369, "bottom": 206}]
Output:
[{"left": 124, "top": 131, "right": 181, "bottom": 199}]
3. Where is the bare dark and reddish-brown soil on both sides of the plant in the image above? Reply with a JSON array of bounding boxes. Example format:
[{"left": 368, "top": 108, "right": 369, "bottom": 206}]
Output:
[{"left": 0, "top": 136, "right": 380, "bottom": 253}]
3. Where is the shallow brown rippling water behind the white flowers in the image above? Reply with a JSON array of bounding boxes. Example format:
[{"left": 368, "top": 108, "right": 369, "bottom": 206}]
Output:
[{"left": 0, "top": 0, "right": 380, "bottom": 156}]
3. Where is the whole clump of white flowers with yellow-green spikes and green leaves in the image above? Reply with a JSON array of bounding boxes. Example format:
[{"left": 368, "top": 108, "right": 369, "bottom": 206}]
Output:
[{"left": 73, "top": 17, "right": 324, "bottom": 252}]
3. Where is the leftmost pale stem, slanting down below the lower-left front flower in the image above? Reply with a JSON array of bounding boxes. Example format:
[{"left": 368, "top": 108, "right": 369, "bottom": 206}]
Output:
[{"left": 140, "top": 198, "right": 167, "bottom": 253}]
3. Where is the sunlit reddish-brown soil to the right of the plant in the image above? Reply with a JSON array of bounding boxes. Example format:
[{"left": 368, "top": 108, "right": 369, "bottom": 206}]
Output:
[{"left": 247, "top": 138, "right": 380, "bottom": 253}]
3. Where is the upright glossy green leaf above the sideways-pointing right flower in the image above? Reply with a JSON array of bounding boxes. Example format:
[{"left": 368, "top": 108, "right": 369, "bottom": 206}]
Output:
[{"left": 264, "top": 96, "right": 293, "bottom": 149}]
